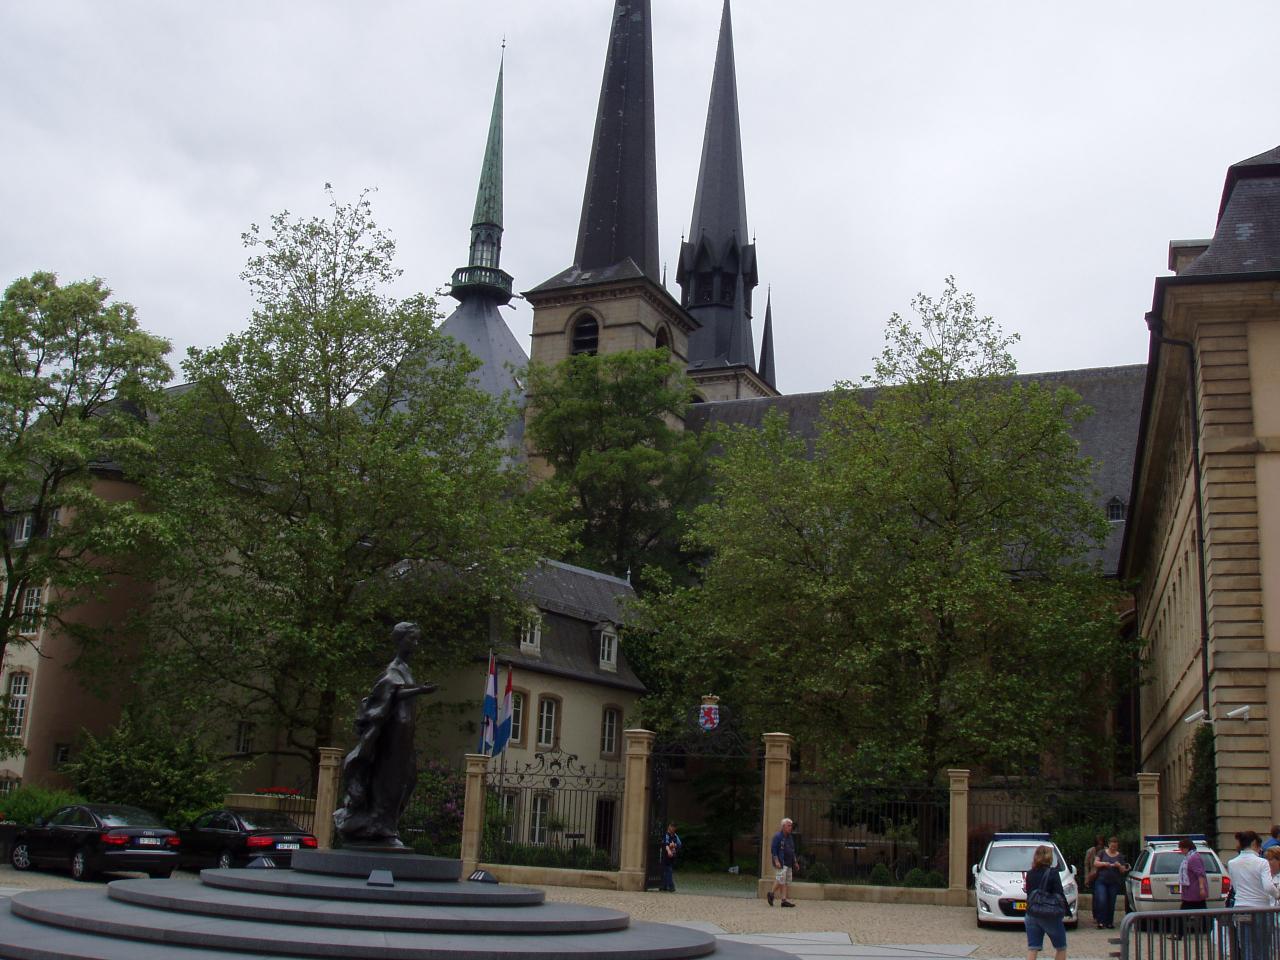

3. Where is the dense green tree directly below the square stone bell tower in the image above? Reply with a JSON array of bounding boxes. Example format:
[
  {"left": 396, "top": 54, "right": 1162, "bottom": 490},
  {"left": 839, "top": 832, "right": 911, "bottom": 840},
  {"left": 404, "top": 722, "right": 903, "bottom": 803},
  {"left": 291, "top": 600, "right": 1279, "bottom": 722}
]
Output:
[{"left": 526, "top": 349, "right": 709, "bottom": 580}]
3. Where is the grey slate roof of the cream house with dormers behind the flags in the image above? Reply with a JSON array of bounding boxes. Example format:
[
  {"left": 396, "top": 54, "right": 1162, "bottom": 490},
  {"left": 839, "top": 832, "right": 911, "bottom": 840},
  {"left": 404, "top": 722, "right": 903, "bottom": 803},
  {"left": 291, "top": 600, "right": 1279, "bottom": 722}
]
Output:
[{"left": 498, "top": 559, "right": 645, "bottom": 694}]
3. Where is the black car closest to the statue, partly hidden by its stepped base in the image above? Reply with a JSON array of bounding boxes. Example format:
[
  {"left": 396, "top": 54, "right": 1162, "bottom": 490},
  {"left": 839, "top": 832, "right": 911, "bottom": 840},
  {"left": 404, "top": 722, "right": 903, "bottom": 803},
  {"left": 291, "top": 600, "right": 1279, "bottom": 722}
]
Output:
[{"left": 182, "top": 806, "right": 316, "bottom": 869}]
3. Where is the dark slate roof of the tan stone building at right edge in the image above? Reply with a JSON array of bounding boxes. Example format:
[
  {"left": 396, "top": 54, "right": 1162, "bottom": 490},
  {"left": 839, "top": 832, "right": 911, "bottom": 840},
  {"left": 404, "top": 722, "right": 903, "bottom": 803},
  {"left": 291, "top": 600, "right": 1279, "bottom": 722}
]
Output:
[{"left": 1179, "top": 147, "right": 1280, "bottom": 278}]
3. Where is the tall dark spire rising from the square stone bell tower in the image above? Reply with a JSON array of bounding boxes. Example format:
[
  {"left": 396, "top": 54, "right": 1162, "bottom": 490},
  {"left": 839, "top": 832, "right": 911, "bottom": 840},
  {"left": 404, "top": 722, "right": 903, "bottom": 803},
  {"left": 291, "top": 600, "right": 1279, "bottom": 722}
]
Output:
[{"left": 573, "top": 0, "right": 660, "bottom": 283}]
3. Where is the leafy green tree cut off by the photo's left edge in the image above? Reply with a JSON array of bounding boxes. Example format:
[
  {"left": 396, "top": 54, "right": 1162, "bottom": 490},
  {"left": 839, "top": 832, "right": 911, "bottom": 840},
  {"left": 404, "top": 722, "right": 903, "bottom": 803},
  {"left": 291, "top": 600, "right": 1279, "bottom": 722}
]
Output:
[{"left": 0, "top": 273, "right": 170, "bottom": 754}]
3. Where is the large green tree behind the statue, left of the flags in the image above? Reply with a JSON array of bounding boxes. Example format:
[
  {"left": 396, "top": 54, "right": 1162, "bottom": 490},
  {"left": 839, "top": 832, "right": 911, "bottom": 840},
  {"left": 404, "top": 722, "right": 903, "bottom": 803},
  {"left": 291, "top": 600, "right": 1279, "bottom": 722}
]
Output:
[{"left": 127, "top": 193, "right": 559, "bottom": 764}]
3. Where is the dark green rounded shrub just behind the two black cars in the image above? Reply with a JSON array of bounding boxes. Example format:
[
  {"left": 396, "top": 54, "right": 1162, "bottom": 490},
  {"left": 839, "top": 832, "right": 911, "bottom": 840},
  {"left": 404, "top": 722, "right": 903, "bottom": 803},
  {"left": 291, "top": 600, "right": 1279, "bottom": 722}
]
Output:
[{"left": 64, "top": 714, "right": 230, "bottom": 827}]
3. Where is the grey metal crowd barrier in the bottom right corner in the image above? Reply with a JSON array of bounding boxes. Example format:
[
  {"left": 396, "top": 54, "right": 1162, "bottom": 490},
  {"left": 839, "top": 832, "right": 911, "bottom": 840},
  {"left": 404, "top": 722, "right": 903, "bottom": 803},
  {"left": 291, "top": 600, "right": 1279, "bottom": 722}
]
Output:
[{"left": 1112, "top": 906, "right": 1280, "bottom": 960}]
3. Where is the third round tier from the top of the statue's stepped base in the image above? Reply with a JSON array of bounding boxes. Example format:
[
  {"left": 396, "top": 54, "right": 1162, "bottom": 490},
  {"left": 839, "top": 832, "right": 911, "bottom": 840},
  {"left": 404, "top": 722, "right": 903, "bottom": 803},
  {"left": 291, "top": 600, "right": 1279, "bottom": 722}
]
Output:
[{"left": 106, "top": 879, "right": 631, "bottom": 934}]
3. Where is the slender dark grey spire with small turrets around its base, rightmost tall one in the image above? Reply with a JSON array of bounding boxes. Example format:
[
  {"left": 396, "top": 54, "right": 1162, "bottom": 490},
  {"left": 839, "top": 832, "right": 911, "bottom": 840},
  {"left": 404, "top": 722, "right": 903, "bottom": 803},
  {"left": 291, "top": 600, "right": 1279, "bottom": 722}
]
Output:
[{"left": 676, "top": 0, "right": 758, "bottom": 370}]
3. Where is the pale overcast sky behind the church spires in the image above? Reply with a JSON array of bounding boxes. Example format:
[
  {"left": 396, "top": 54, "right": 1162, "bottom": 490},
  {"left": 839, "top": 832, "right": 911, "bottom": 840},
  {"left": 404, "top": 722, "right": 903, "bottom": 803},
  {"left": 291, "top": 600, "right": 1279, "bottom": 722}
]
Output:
[{"left": 0, "top": 0, "right": 1280, "bottom": 393}]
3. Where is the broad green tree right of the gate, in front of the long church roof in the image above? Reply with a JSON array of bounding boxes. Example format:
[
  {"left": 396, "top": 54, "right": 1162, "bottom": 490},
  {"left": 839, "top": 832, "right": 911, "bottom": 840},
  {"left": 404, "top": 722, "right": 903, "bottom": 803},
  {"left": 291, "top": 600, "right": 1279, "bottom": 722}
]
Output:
[{"left": 630, "top": 280, "right": 1133, "bottom": 782}]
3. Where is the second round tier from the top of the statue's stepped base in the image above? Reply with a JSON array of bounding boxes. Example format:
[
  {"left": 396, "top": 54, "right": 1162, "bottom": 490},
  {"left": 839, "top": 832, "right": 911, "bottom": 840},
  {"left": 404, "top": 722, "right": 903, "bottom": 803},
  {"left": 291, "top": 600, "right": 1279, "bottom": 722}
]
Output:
[{"left": 200, "top": 868, "right": 547, "bottom": 906}]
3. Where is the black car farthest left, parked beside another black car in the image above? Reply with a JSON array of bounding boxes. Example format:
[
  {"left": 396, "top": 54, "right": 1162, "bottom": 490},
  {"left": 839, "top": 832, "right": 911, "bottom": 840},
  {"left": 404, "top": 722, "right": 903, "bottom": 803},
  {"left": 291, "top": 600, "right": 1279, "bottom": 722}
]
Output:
[{"left": 9, "top": 804, "right": 180, "bottom": 879}]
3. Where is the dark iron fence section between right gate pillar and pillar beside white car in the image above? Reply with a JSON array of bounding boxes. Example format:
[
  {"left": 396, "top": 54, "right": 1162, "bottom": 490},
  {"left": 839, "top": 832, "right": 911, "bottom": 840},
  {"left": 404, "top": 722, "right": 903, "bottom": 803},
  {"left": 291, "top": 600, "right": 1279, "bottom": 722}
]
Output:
[{"left": 787, "top": 783, "right": 951, "bottom": 887}]
